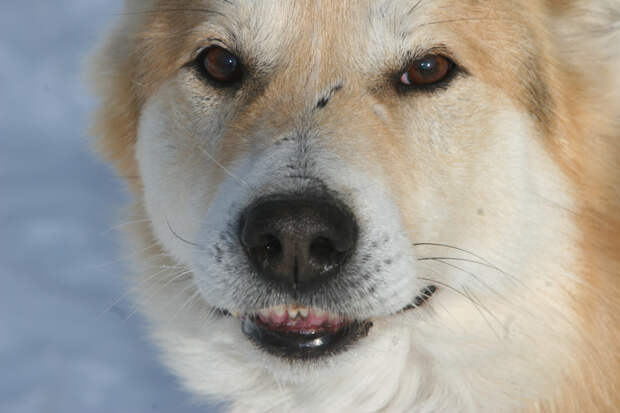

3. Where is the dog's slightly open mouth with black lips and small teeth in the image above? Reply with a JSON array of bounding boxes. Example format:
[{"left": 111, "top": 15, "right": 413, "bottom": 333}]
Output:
[{"left": 218, "top": 285, "right": 436, "bottom": 360}]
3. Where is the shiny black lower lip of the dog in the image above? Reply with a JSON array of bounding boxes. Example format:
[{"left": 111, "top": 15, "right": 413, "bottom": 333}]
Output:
[{"left": 241, "top": 317, "right": 372, "bottom": 360}]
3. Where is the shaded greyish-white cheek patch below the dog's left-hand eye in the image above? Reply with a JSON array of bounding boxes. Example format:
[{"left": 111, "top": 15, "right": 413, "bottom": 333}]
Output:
[{"left": 136, "top": 80, "right": 221, "bottom": 264}]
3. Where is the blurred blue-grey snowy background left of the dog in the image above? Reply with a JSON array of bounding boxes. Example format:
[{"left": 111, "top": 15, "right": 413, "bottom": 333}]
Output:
[{"left": 0, "top": 0, "right": 220, "bottom": 413}]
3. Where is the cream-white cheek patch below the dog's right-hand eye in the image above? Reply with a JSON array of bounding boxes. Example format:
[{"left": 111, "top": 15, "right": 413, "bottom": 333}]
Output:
[{"left": 332, "top": 83, "right": 576, "bottom": 308}]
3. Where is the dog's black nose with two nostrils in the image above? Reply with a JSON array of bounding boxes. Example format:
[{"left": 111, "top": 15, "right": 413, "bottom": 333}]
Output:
[{"left": 240, "top": 197, "right": 357, "bottom": 288}]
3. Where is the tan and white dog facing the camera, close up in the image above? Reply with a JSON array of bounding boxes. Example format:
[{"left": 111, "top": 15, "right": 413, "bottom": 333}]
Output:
[{"left": 90, "top": 0, "right": 620, "bottom": 413}]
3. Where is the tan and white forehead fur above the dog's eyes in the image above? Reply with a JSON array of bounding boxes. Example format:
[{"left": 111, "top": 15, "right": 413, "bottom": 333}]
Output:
[{"left": 177, "top": 0, "right": 538, "bottom": 83}]
